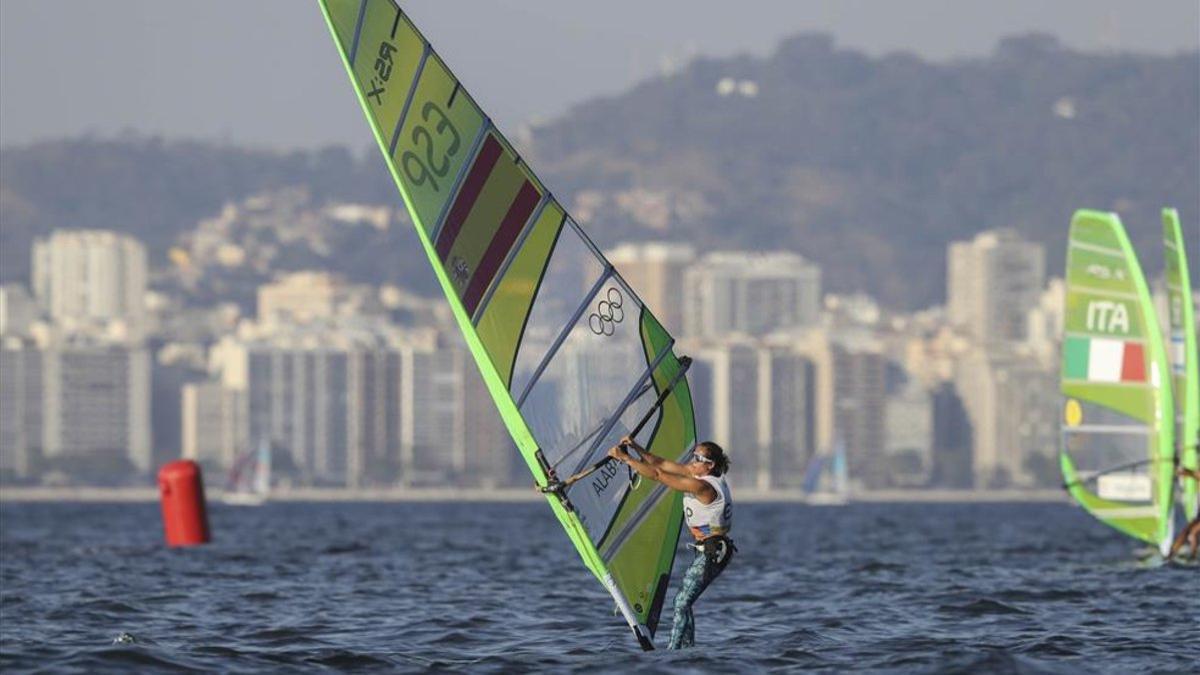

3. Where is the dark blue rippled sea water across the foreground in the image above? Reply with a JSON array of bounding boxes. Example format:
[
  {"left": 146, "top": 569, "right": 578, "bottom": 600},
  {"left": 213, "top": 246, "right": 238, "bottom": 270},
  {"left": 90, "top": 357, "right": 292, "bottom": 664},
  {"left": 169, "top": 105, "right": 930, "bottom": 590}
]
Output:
[{"left": 0, "top": 503, "right": 1200, "bottom": 673}]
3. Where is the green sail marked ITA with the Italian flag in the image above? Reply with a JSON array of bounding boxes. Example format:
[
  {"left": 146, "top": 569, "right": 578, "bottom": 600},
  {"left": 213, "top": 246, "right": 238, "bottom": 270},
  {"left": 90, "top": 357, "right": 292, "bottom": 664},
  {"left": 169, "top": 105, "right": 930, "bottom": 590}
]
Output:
[{"left": 1060, "top": 210, "right": 1175, "bottom": 555}]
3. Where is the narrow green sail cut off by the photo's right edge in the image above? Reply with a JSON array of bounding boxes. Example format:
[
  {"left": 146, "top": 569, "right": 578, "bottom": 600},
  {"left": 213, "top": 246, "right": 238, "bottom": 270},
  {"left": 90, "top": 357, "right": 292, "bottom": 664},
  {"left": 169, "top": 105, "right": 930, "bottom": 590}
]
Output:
[{"left": 1163, "top": 209, "right": 1200, "bottom": 520}]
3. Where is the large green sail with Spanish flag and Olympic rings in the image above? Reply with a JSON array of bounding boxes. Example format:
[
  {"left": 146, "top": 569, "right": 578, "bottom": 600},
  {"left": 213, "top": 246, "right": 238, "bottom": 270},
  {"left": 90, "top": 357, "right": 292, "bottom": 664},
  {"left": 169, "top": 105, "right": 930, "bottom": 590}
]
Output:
[{"left": 319, "top": 0, "right": 696, "bottom": 649}]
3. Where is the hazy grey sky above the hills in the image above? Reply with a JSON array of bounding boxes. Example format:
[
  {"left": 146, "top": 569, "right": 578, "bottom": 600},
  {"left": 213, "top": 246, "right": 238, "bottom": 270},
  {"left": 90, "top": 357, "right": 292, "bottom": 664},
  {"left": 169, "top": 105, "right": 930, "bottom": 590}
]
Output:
[{"left": 0, "top": 0, "right": 1200, "bottom": 149}]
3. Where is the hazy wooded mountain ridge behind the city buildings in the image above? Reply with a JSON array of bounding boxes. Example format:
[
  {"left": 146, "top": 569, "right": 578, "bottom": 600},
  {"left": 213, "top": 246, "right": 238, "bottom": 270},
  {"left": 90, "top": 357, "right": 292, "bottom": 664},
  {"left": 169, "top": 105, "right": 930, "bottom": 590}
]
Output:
[{"left": 0, "top": 34, "right": 1200, "bottom": 309}]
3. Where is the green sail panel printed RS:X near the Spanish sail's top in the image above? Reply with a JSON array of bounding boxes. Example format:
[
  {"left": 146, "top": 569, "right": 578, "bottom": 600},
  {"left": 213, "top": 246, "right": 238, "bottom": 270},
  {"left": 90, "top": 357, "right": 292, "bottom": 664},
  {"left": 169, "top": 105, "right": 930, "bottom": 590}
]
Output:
[{"left": 350, "top": 0, "right": 425, "bottom": 142}]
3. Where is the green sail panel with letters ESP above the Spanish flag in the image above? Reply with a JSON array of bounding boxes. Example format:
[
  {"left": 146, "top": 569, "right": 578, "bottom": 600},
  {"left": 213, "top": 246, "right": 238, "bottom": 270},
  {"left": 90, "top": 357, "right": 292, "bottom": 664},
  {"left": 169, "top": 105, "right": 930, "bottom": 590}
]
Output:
[{"left": 388, "top": 53, "right": 486, "bottom": 237}]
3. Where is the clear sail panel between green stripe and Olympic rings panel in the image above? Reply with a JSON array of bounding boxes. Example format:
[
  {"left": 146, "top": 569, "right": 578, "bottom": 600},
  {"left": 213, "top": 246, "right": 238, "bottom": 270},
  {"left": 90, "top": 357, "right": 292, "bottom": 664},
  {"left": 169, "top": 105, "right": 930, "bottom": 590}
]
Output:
[{"left": 509, "top": 220, "right": 609, "bottom": 400}]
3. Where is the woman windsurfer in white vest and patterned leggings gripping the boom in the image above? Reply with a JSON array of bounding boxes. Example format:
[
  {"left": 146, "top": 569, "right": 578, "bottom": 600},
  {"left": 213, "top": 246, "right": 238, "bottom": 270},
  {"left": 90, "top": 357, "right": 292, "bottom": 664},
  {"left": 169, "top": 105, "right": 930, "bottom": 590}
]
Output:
[{"left": 608, "top": 436, "right": 737, "bottom": 650}]
